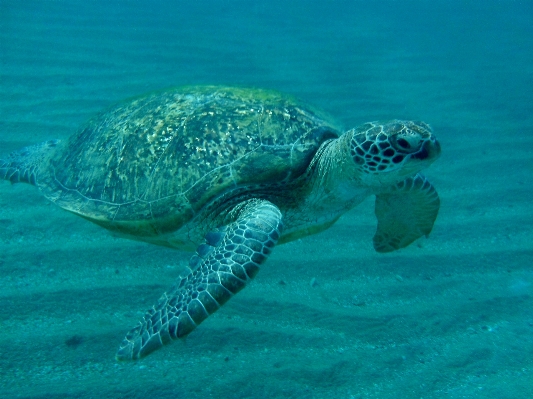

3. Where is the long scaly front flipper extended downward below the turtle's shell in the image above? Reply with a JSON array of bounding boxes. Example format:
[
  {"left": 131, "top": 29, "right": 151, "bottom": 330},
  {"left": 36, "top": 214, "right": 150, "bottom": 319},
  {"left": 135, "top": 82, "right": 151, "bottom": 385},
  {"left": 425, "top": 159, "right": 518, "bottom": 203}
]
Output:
[{"left": 116, "top": 200, "right": 282, "bottom": 360}]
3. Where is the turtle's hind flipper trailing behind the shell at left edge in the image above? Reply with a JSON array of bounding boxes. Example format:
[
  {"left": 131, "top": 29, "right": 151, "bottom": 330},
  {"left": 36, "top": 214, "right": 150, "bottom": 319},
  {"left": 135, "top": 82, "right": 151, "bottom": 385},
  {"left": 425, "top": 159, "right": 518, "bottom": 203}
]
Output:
[{"left": 0, "top": 140, "right": 59, "bottom": 186}]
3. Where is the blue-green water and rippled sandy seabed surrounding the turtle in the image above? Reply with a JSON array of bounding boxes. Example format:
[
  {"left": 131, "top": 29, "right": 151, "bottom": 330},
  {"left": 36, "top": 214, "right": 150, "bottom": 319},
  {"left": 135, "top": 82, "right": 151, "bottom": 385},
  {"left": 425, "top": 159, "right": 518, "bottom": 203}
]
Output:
[{"left": 0, "top": 0, "right": 533, "bottom": 399}]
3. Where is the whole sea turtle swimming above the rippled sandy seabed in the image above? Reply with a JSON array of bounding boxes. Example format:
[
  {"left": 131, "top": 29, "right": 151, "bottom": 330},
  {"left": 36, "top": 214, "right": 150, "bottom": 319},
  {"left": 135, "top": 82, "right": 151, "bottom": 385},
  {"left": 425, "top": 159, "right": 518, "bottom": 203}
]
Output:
[{"left": 0, "top": 86, "right": 440, "bottom": 360}]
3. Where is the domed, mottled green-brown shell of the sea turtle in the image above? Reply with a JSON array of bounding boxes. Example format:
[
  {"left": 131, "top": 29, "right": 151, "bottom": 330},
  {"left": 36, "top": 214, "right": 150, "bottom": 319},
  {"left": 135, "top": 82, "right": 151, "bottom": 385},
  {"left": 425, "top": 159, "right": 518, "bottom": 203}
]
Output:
[{"left": 39, "top": 86, "right": 338, "bottom": 235}]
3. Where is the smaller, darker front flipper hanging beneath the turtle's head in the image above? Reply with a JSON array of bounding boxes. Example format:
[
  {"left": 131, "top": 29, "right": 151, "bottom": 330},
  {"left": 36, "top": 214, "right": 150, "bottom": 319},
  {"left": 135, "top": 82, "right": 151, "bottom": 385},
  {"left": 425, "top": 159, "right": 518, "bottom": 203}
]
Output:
[{"left": 374, "top": 174, "right": 440, "bottom": 252}]
